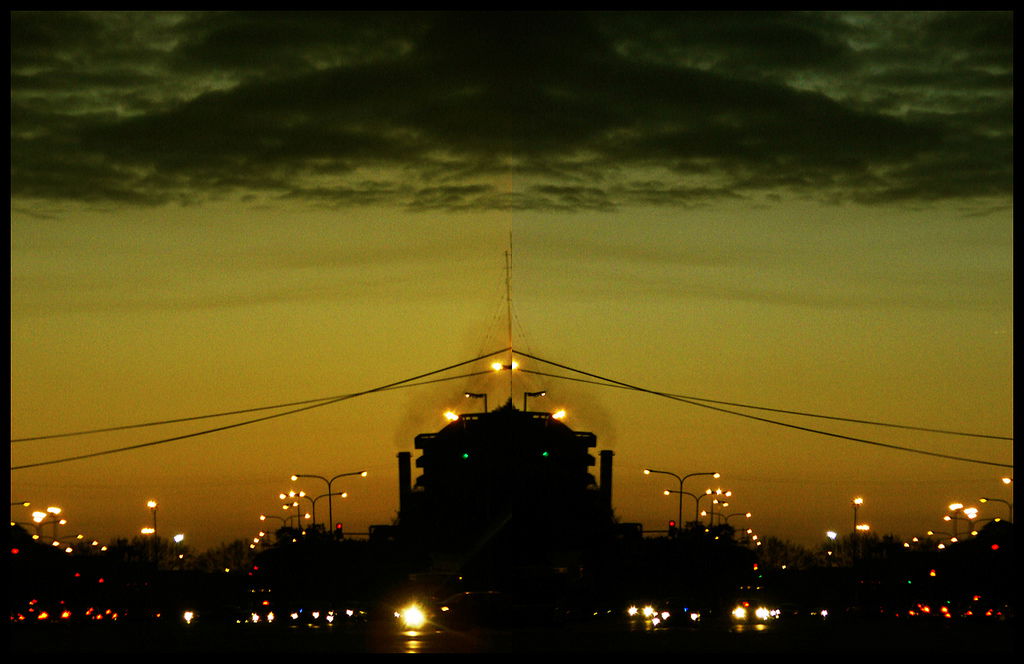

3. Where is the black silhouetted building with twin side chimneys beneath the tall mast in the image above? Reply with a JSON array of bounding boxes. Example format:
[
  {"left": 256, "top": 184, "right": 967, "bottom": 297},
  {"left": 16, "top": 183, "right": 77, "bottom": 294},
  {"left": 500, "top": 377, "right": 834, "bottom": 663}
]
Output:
[{"left": 395, "top": 402, "right": 613, "bottom": 580}]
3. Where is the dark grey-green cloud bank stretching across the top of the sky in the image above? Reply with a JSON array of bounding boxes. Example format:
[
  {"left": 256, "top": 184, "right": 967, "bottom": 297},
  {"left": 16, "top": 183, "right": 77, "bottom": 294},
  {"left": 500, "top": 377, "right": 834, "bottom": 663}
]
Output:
[{"left": 11, "top": 12, "right": 1013, "bottom": 210}]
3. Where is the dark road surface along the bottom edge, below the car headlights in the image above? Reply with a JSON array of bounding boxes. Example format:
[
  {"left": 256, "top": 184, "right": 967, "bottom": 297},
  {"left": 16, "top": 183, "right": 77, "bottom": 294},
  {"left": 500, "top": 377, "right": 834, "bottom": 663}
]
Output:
[{"left": 9, "top": 620, "right": 1015, "bottom": 655}]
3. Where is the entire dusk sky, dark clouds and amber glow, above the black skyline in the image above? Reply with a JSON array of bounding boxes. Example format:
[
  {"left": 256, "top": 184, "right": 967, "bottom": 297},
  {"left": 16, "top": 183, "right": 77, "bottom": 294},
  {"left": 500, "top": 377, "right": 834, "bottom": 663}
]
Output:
[{"left": 10, "top": 12, "right": 1013, "bottom": 548}]
